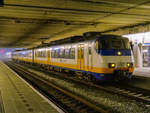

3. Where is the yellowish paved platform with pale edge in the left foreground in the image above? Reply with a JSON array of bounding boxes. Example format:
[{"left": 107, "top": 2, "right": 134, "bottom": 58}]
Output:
[{"left": 0, "top": 62, "right": 63, "bottom": 113}]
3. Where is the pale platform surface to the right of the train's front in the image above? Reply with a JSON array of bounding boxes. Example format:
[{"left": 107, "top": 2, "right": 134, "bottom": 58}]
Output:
[{"left": 133, "top": 67, "right": 150, "bottom": 77}]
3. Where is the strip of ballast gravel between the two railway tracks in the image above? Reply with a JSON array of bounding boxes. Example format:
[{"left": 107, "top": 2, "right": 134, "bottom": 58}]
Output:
[{"left": 25, "top": 66, "right": 150, "bottom": 113}]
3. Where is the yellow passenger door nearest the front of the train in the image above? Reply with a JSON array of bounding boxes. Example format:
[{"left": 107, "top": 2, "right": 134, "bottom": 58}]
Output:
[{"left": 78, "top": 44, "right": 84, "bottom": 70}]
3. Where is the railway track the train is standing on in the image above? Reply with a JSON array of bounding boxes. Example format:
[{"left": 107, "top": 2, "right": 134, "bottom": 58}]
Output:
[{"left": 12, "top": 61, "right": 150, "bottom": 106}]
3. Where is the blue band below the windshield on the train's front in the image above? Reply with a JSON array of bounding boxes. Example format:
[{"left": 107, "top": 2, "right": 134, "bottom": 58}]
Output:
[{"left": 98, "top": 49, "right": 131, "bottom": 56}]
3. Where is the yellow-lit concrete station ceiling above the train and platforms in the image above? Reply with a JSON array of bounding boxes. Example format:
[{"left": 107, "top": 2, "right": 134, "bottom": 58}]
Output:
[{"left": 0, "top": 0, "right": 150, "bottom": 48}]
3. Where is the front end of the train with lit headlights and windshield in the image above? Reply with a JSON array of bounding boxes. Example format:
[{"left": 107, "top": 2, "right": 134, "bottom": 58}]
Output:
[{"left": 95, "top": 35, "right": 134, "bottom": 81}]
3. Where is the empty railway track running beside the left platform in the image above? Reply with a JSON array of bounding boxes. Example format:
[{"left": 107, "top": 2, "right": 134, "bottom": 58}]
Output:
[{"left": 6, "top": 62, "right": 108, "bottom": 113}]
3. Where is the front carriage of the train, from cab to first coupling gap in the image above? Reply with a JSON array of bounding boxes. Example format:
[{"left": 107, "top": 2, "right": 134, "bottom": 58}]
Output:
[{"left": 11, "top": 35, "right": 134, "bottom": 80}]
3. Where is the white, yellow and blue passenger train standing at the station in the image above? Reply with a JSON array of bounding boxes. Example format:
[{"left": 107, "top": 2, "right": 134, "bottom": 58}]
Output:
[{"left": 12, "top": 32, "right": 134, "bottom": 81}]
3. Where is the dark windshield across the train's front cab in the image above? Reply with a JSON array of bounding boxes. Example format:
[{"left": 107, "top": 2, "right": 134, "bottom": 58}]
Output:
[{"left": 99, "top": 37, "right": 130, "bottom": 49}]
